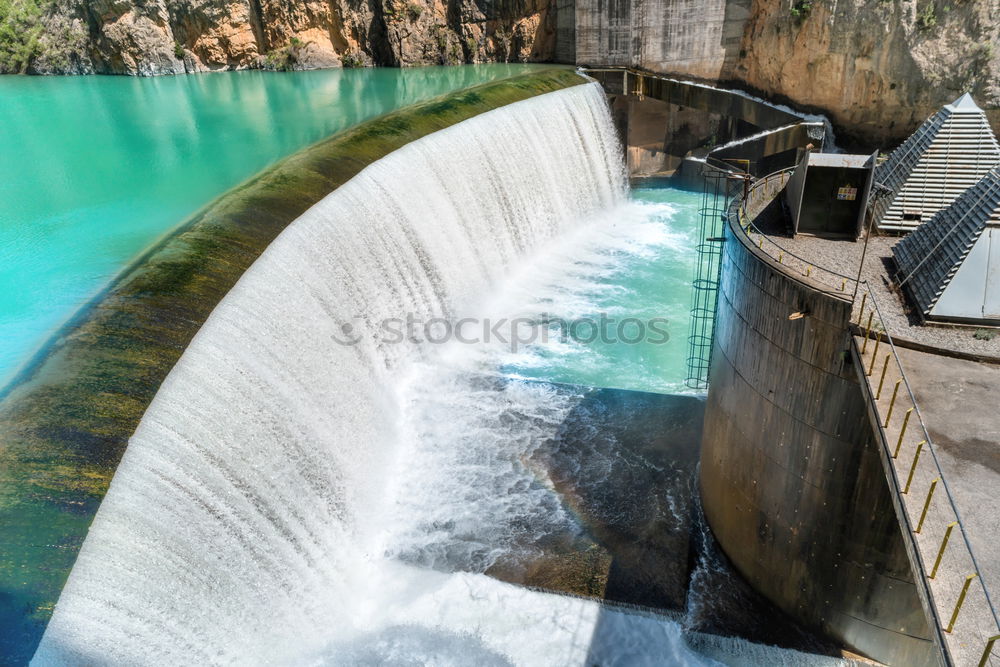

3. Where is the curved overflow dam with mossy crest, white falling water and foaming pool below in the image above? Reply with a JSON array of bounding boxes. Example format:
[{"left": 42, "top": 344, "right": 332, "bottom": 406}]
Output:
[{"left": 0, "top": 69, "right": 864, "bottom": 665}]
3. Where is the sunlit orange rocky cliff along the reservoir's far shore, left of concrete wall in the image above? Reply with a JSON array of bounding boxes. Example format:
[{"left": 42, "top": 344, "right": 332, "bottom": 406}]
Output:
[{"left": 27, "top": 0, "right": 555, "bottom": 75}]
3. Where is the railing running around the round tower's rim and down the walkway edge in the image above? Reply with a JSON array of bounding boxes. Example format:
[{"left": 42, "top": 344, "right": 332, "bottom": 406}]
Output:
[{"left": 729, "top": 169, "right": 1000, "bottom": 667}]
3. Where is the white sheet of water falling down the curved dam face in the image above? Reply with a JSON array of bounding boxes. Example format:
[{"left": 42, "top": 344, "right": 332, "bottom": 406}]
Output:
[{"left": 35, "top": 84, "right": 626, "bottom": 664}]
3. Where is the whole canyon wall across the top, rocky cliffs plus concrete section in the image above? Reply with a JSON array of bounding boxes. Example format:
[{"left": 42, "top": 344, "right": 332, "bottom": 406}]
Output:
[{"left": 0, "top": 0, "right": 1000, "bottom": 160}]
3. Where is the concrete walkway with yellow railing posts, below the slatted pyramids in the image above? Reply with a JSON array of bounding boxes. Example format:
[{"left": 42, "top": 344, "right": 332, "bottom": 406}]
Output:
[{"left": 854, "top": 337, "right": 1000, "bottom": 665}]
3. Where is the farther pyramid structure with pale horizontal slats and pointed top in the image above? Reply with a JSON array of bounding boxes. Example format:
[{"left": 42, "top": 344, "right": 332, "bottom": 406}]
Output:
[{"left": 872, "top": 93, "right": 1000, "bottom": 233}]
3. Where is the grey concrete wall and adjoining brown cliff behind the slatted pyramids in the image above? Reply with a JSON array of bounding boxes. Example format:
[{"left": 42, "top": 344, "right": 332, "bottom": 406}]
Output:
[{"left": 572, "top": 0, "right": 1000, "bottom": 146}]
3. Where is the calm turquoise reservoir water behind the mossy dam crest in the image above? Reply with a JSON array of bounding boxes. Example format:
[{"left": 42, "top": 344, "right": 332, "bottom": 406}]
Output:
[{"left": 0, "top": 65, "right": 537, "bottom": 385}]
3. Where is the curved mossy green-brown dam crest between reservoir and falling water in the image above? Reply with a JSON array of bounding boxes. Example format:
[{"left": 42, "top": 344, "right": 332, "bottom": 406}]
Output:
[{"left": 0, "top": 68, "right": 585, "bottom": 659}]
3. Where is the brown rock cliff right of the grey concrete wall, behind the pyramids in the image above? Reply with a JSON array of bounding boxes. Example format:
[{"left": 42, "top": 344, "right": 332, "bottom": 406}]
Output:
[{"left": 722, "top": 0, "right": 1000, "bottom": 144}]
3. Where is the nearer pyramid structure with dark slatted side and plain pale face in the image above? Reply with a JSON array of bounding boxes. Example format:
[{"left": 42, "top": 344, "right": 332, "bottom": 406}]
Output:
[{"left": 893, "top": 168, "right": 1000, "bottom": 317}]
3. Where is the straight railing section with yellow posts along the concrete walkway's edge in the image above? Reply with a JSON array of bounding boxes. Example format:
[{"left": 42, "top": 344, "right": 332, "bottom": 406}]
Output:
[{"left": 852, "top": 281, "right": 1000, "bottom": 667}]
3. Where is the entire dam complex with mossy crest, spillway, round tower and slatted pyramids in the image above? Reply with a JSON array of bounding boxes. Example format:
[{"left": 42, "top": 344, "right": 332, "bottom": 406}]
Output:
[{"left": 0, "top": 17, "right": 1000, "bottom": 666}]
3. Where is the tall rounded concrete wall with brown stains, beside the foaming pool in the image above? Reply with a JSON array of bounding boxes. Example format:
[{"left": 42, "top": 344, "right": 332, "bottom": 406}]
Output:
[{"left": 701, "top": 181, "right": 938, "bottom": 665}]
